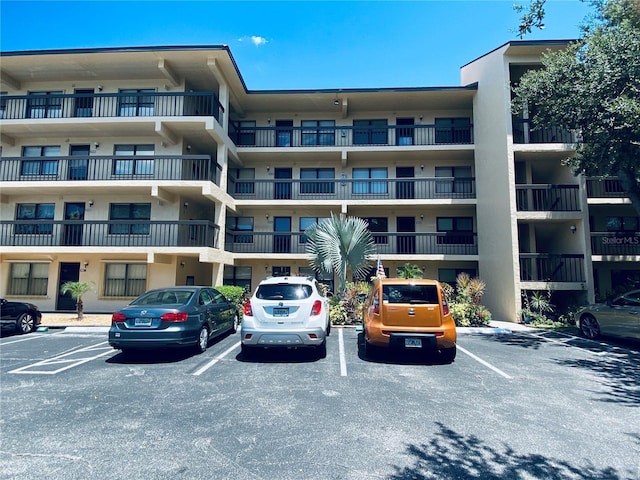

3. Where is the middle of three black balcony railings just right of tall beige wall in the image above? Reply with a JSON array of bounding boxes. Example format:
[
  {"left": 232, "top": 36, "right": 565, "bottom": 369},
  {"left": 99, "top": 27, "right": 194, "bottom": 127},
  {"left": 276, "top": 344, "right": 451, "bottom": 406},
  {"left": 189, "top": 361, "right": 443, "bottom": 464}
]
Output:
[{"left": 516, "top": 185, "right": 580, "bottom": 212}]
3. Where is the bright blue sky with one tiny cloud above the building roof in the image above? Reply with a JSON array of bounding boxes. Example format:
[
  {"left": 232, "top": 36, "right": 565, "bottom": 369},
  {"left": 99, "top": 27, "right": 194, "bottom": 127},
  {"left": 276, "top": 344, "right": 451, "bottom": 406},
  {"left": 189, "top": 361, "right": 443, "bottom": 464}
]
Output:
[{"left": 0, "top": 0, "right": 592, "bottom": 90}]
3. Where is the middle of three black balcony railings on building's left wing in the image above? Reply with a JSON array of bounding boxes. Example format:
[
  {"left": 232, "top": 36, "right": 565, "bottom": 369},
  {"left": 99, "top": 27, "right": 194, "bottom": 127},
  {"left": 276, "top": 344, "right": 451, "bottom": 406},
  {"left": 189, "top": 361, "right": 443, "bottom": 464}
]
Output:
[{"left": 0, "top": 155, "right": 222, "bottom": 185}]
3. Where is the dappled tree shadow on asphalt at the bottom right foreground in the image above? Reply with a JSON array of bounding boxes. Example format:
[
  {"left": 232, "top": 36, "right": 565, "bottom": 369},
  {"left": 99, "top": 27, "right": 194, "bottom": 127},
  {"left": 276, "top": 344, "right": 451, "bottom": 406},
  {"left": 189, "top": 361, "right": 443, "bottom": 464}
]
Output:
[{"left": 388, "top": 423, "right": 635, "bottom": 480}]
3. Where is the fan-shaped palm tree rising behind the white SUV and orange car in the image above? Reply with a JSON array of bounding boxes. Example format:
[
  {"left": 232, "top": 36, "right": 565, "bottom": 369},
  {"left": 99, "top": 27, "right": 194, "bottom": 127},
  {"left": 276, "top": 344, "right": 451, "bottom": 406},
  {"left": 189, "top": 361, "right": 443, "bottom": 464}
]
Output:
[{"left": 304, "top": 213, "right": 376, "bottom": 293}]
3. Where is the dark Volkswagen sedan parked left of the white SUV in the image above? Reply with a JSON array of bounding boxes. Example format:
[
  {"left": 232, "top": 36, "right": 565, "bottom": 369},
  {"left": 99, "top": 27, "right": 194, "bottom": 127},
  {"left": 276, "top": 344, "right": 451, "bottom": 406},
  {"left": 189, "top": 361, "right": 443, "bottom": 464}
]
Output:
[{"left": 109, "top": 286, "right": 240, "bottom": 352}]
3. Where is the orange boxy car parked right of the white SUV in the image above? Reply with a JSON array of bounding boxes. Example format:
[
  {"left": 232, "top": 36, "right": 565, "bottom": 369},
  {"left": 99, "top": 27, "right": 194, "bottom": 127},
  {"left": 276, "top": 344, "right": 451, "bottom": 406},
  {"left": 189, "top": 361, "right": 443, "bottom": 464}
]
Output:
[{"left": 363, "top": 278, "right": 456, "bottom": 363}]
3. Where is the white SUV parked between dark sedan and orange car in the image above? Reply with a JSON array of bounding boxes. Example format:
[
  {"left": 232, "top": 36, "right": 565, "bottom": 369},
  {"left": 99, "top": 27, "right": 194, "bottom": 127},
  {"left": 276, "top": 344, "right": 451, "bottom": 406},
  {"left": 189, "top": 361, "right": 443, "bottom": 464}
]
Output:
[{"left": 240, "top": 276, "right": 331, "bottom": 357}]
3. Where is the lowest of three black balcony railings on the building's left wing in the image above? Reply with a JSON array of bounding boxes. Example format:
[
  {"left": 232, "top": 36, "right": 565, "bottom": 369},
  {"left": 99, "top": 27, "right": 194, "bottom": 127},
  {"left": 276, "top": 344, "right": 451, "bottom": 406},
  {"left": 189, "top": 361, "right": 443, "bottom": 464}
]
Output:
[{"left": 0, "top": 220, "right": 220, "bottom": 248}]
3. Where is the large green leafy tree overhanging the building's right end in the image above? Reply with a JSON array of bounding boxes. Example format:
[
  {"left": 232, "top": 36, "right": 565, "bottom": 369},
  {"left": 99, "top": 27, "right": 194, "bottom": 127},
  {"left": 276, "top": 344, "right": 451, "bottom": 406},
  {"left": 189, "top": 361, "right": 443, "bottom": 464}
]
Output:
[{"left": 512, "top": 0, "right": 640, "bottom": 215}]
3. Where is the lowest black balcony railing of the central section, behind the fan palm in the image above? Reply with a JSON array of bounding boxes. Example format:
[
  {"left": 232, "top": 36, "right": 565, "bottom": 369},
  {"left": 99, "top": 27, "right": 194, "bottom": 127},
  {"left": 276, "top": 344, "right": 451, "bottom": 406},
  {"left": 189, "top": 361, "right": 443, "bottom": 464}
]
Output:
[{"left": 225, "top": 231, "right": 478, "bottom": 255}]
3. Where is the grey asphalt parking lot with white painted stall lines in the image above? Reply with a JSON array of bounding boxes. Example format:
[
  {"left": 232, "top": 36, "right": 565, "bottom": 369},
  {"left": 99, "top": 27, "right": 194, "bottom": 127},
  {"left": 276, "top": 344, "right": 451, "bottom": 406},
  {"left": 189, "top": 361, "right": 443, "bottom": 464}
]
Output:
[{"left": 0, "top": 328, "right": 640, "bottom": 479}]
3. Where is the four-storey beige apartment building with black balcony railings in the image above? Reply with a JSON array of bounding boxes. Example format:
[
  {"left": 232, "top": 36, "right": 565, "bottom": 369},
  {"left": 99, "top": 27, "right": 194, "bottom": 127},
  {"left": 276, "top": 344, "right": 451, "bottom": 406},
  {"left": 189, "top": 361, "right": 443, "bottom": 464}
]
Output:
[{"left": 0, "top": 42, "right": 640, "bottom": 321}]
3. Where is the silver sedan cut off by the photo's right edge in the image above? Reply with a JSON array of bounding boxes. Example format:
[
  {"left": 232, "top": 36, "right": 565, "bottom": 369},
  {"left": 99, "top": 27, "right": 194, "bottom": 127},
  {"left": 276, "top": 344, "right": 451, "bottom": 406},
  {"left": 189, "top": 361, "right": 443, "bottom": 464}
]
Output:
[{"left": 577, "top": 290, "right": 640, "bottom": 339}]
